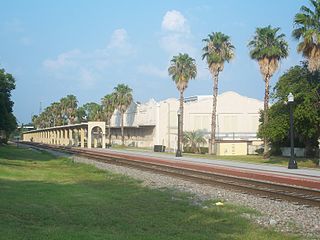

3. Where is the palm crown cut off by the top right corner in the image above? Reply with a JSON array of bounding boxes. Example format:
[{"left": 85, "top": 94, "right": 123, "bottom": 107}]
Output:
[{"left": 292, "top": 0, "right": 320, "bottom": 72}]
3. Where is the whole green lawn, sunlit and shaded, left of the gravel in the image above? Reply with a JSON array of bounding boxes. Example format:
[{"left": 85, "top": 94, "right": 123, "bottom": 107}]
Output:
[{"left": 0, "top": 146, "right": 299, "bottom": 240}]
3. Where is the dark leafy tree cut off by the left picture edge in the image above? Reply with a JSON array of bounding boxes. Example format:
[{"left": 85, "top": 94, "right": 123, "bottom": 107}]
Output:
[{"left": 0, "top": 69, "right": 17, "bottom": 143}]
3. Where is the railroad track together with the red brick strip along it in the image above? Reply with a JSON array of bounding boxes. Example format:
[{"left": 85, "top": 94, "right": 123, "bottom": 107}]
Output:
[{"left": 19, "top": 142, "right": 320, "bottom": 207}]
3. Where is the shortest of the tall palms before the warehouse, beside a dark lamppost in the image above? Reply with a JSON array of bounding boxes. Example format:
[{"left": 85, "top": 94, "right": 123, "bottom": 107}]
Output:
[{"left": 168, "top": 53, "right": 197, "bottom": 150}]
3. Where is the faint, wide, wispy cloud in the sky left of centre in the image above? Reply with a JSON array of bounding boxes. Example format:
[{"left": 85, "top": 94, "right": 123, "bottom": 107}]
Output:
[{"left": 42, "top": 29, "right": 135, "bottom": 87}]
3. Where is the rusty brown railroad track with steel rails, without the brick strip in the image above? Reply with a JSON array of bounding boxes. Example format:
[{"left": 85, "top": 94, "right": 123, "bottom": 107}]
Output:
[{"left": 19, "top": 143, "right": 320, "bottom": 207}]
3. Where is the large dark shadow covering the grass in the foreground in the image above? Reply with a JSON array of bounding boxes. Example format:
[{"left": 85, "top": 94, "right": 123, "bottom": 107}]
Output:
[{"left": 0, "top": 178, "right": 291, "bottom": 240}]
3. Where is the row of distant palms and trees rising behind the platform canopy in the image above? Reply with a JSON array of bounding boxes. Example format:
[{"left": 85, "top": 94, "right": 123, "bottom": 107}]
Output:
[{"left": 32, "top": 84, "right": 133, "bottom": 144}]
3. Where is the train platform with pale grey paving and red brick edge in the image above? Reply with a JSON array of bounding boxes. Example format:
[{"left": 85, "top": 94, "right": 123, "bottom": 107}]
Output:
[{"left": 94, "top": 149, "right": 320, "bottom": 191}]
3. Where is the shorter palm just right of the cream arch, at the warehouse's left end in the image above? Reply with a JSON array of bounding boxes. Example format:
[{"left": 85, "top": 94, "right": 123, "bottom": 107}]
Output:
[{"left": 114, "top": 84, "right": 133, "bottom": 146}]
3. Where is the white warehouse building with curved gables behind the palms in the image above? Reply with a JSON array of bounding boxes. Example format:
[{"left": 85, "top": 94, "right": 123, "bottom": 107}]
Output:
[{"left": 111, "top": 91, "right": 263, "bottom": 154}]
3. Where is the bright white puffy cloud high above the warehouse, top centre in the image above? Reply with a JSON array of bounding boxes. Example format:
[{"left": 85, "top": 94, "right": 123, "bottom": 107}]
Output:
[{"left": 161, "top": 10, "right": 189, "bottom": 32}]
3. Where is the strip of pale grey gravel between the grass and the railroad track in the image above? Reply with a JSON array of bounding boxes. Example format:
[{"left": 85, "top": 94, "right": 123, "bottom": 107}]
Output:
[{"left": 73, "top": 157, "right": 320, "bottom": 239}]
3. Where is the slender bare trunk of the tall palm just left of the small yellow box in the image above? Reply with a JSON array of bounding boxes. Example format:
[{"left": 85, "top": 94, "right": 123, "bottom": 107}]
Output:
[{"left": 209, "top": 71, "right": 219, "bottom": 154}]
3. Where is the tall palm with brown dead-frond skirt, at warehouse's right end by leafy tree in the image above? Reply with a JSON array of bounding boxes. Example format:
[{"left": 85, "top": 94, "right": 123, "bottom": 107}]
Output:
[{"left": 248, "top": 25, "right": 288, "bottom": 158}]
